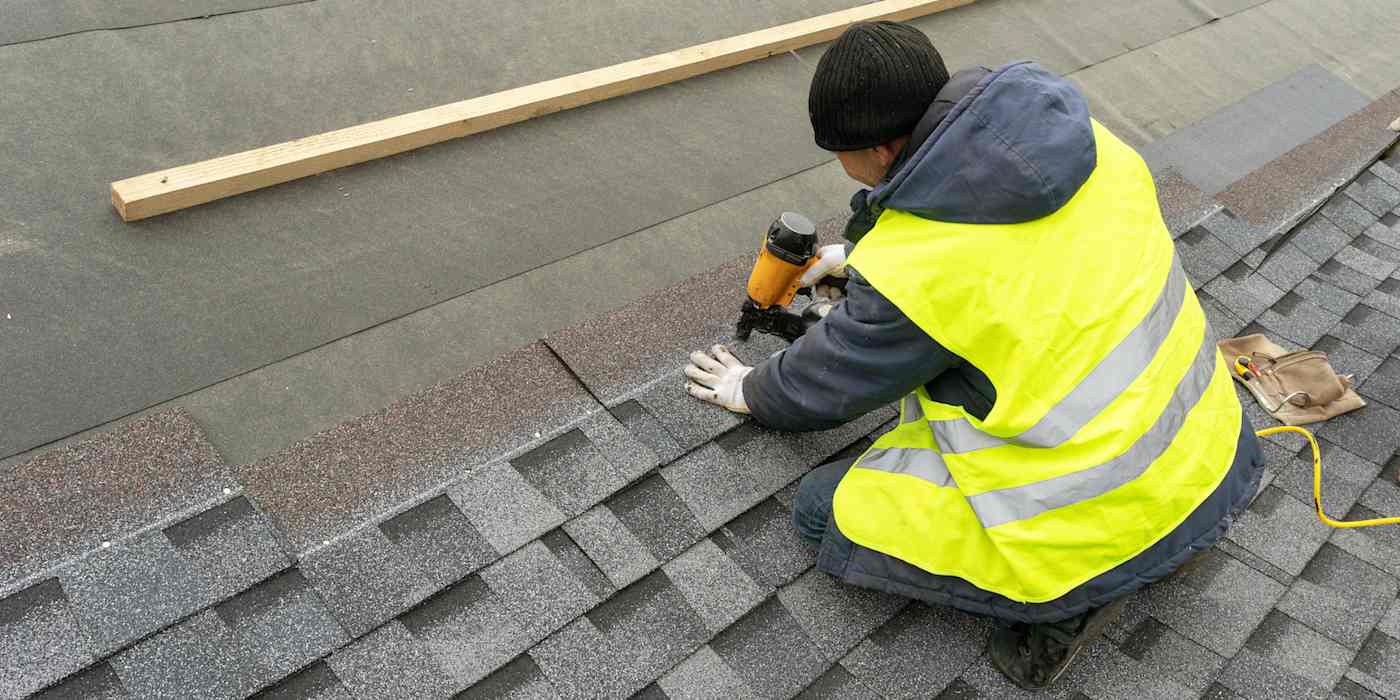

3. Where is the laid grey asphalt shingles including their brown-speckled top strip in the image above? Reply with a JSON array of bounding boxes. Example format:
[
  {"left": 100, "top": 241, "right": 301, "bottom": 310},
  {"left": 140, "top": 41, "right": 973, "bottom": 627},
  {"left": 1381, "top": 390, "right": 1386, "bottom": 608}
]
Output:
[{"left": 0, "top": 99, "right": 1400, "bottom": 700}]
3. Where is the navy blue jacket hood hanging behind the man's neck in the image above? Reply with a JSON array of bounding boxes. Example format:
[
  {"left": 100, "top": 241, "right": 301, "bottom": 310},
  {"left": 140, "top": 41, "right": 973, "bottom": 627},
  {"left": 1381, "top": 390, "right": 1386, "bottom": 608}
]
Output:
[{"left": 865, "top": 62, "right": 1098, "bottom": 224}]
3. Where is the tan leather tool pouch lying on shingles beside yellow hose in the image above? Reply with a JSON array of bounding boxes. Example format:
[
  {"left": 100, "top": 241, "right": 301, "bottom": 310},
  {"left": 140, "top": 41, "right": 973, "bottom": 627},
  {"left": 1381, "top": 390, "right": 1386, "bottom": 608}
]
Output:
[{"left": 1219, "top": 333, "right": 1366, "bottom": 426}]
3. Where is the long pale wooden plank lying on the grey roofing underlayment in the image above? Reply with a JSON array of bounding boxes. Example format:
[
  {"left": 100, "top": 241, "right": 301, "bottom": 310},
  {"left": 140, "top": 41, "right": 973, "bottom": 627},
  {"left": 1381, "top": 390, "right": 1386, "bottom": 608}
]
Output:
[{"left": 112, "top": 0, "right": 974, "bottom": 221}]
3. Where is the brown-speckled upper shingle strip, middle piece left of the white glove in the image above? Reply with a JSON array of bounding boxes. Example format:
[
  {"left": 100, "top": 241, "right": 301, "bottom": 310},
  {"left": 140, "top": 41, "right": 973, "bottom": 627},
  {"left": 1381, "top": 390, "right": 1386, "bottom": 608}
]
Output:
[{"left": 239, "top": 343, "right": 601, "bottom": 552}]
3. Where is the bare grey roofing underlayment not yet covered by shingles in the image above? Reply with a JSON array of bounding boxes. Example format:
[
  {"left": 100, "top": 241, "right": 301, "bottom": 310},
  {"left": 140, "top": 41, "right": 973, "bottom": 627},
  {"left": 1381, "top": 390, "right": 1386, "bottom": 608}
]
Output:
[{"left": 8, "top": 0, "right": 1400, "bottom": 473}]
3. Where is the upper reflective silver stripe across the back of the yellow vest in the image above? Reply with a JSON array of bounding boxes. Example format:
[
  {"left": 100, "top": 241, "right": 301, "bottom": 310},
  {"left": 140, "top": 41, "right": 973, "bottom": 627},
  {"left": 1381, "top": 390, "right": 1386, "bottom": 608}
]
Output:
[{"left": 930, "top": 255, "right": 1186, "bottom": 455}]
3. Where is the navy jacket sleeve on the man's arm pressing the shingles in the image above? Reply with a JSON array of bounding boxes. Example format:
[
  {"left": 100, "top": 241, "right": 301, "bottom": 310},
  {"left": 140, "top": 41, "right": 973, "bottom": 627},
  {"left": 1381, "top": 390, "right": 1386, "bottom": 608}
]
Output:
[{"left": 743, "top": 267, "right": 962, "bottom": 431}]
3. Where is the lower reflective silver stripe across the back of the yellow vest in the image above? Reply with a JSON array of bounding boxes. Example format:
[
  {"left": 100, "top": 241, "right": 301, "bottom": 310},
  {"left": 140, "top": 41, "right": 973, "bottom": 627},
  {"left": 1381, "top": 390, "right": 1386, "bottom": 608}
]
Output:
[{"left": 967, "top": 333, "right": 1215, "bottom": 528}]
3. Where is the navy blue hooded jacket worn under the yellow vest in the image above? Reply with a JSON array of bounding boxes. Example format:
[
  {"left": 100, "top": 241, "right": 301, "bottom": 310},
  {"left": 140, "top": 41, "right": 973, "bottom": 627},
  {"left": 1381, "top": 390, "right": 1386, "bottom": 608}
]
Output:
[{"left": 743, "top": 63, "right": 1263, "bottom": 623}]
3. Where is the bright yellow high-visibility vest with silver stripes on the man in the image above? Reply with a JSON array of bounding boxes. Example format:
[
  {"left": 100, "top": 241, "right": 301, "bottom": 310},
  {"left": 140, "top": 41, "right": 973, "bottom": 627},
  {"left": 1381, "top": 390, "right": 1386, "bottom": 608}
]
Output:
[{"left": 833, "top": 123, "right": 1242, "bottom": 603}]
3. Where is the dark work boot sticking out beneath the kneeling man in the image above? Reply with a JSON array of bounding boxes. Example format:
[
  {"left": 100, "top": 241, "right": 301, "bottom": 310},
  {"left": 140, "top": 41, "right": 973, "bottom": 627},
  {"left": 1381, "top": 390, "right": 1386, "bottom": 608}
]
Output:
[{"left": 987, "top": 598, "right": 1126, "bottom": 690}]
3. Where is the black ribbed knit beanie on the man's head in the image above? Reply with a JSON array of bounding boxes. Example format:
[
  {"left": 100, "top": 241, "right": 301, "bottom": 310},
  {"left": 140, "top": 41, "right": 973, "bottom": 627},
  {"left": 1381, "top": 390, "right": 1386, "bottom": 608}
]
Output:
[{"left": 806, "top": 22, "right": 948, "bottom": 151}]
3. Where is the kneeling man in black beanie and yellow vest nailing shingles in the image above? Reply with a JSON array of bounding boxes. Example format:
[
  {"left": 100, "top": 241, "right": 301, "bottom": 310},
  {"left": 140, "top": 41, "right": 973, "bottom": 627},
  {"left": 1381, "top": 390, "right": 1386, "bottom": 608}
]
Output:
[{"left": 686, "top": 22, "right": 1261, "bottom": 687}]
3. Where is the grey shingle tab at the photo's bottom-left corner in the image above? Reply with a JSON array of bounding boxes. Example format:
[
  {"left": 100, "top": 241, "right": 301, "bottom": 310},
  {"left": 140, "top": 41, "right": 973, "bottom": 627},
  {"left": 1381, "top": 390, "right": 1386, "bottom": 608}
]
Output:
[{"left": 0, "top": 578, "right": 92, "bottom": 697}]
